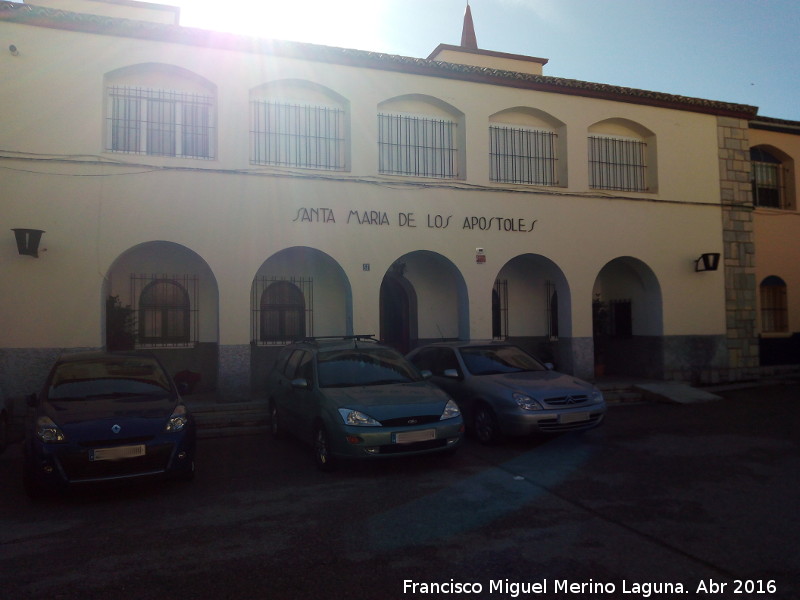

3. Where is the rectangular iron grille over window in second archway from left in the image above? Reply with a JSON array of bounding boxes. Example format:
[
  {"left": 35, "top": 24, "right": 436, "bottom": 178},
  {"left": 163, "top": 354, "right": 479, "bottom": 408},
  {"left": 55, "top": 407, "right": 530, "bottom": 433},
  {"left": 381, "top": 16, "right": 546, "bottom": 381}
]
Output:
[{"left": 251, "top": 276, "right": 314, "bottom": 345}]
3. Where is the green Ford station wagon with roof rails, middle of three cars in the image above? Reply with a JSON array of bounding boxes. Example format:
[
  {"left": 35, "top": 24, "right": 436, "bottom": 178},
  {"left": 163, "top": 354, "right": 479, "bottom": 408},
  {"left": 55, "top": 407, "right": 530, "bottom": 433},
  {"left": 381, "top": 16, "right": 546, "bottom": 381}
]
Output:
[{"left": 268, "top": 336, "right": 464, "bottom": 470}]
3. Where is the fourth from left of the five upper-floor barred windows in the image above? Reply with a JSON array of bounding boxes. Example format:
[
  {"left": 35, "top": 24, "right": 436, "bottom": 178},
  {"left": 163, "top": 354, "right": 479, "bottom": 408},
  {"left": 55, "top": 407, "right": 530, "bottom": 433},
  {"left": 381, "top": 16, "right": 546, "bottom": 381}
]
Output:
[{"left": 489, "top": 125, "right": 558, "bottom": 185}]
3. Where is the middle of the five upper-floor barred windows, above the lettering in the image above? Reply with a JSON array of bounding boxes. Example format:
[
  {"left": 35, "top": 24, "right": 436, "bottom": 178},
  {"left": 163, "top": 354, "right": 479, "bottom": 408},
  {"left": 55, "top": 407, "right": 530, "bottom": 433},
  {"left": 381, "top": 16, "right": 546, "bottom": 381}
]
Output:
[{"left": 378, "top": 114, "right": 458, "bottom": 178}]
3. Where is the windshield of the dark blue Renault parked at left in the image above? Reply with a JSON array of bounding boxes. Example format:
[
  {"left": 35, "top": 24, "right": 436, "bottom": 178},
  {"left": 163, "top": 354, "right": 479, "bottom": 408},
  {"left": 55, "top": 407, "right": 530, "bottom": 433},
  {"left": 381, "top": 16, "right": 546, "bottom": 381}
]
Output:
[{"left": 47, "top": 357, "right": 170, "bottom": 400}]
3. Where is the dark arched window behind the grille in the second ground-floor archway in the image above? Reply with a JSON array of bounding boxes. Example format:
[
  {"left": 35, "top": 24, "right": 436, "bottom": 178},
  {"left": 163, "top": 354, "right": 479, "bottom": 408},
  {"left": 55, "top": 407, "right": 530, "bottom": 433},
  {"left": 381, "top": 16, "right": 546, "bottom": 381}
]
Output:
[{"left": 260, "top": 281, "right": 306, "bottom": 342}]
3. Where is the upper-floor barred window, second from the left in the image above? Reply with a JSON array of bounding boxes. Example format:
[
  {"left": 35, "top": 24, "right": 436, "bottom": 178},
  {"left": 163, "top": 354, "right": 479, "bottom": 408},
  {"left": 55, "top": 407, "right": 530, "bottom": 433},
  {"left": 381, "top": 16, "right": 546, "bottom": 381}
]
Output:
[{"left": 250, "top": 100, "right": 346, "bottom": 171}]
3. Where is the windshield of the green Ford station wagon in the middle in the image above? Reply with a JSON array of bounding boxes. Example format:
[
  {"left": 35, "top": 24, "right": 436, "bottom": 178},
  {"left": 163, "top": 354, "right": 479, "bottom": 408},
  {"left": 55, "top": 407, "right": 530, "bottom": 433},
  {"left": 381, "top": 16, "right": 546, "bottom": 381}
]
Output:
[{"left": 317, "top": 348, "right": 422, "bottom": 388}]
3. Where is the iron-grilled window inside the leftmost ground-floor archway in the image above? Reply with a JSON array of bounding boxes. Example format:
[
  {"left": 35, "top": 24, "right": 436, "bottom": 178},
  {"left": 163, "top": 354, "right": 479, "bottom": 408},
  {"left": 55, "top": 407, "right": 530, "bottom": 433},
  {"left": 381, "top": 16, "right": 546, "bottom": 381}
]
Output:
[{"left": 131, "top": 274, "right": 199, "bottom": 347}]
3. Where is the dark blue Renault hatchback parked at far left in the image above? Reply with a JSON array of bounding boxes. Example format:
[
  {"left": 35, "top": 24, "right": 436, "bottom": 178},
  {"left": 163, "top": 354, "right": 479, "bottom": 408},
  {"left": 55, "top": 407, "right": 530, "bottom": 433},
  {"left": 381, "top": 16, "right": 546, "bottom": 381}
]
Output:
[{"left": 23, "top": 352, "right": 196, "bottom": 498}]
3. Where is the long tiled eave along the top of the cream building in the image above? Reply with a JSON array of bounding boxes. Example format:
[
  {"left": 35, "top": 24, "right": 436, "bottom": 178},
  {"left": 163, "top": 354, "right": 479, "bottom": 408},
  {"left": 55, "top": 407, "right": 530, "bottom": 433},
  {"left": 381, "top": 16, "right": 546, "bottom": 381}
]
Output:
[{"left": 0, "top": 0, "right": 758, "bottom": 120}]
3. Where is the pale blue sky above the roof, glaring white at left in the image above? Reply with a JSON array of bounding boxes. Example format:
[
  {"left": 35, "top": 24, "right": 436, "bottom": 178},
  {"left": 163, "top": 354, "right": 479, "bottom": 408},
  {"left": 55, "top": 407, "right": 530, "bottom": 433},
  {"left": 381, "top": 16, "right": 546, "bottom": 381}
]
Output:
[{"left": 172, "top": 0, "right": 800, "bottom": 121}]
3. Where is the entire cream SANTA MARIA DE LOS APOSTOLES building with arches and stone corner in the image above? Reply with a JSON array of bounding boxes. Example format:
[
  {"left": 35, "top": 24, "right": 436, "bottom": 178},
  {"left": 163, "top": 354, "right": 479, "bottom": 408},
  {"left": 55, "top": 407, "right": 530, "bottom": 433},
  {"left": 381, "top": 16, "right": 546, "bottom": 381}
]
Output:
[{"left": 0, "top": 0, "right": 776, "bottom": 404}]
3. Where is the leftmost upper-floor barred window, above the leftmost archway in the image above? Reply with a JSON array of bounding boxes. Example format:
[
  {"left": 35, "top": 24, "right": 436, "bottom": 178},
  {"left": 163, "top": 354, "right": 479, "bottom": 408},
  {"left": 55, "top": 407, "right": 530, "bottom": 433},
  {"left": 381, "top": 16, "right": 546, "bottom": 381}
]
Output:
[{"left": 106, "top": 86, "right": 215, "bottom": 159}]
